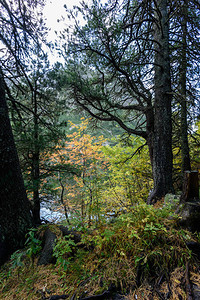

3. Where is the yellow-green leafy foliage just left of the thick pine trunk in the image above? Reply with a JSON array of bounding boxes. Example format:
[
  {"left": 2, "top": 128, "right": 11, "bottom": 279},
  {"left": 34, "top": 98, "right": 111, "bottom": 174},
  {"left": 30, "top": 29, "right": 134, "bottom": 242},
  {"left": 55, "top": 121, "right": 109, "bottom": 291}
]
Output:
[{"left": 103, "top": 137, "right": 153, "bottom": 213}]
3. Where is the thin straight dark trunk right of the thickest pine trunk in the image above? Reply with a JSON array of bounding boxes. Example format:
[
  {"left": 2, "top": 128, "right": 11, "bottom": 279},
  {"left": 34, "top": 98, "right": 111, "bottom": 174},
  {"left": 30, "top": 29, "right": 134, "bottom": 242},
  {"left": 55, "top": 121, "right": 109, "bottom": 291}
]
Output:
[{"left": 179, "top": 0, "right": 191, "bottom": 172}]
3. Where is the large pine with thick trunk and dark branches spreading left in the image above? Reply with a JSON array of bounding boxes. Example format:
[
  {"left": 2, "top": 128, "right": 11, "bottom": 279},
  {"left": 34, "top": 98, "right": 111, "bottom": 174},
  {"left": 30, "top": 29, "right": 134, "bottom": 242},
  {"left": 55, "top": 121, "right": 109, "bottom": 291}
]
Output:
[{"left": 59, "top": 1, "right": 199, "bottom": 202}]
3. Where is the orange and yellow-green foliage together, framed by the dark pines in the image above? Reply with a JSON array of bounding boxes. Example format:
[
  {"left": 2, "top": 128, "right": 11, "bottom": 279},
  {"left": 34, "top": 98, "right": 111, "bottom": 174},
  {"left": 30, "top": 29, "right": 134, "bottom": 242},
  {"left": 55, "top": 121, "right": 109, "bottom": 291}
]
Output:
[{"left": 49, "top": 118, "right": 153, "bottom": 224}]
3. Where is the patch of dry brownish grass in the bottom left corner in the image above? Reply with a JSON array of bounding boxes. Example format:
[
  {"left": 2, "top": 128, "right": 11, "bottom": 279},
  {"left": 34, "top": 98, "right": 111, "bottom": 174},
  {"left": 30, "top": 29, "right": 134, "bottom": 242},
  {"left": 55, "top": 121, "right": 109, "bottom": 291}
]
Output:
[{"left": 0, "top": 262, "right": 67, "bottom": 300}]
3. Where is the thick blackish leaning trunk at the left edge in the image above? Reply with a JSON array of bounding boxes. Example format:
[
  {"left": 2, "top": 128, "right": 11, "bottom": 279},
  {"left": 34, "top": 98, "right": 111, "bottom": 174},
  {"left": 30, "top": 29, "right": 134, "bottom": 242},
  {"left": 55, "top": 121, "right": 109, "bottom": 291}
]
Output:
[{"left": 0, "top": 69, "right": 32, "bottom": 264}]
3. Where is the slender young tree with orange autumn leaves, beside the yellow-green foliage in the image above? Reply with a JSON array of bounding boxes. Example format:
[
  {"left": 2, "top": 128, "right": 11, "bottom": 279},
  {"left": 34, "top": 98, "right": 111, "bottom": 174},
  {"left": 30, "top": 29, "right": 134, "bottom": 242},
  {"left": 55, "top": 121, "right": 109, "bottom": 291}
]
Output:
[{"left": 47, "top": 118, "right": 107, "bottom": 225}]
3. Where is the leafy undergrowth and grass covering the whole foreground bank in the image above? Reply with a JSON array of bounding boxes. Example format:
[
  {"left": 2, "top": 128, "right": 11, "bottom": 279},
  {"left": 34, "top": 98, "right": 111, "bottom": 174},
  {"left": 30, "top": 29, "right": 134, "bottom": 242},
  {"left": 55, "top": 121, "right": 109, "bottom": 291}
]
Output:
[{"left": 0, "top": 204, "right": 200, "bottom": 300}]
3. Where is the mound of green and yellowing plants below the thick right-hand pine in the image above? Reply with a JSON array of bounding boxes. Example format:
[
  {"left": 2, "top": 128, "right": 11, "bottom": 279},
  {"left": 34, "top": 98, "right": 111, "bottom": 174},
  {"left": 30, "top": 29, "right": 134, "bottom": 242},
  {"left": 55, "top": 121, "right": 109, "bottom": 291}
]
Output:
[{"left": 46, "top": 202, "right": 193, "bottom": 292}]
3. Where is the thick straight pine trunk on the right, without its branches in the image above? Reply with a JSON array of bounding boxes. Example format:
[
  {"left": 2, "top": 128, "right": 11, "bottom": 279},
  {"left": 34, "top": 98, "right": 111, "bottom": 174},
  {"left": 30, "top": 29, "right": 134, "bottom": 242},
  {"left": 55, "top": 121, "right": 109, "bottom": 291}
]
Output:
[{"left": 148, "top": 0, "right": 173, "bottom": 203}]
